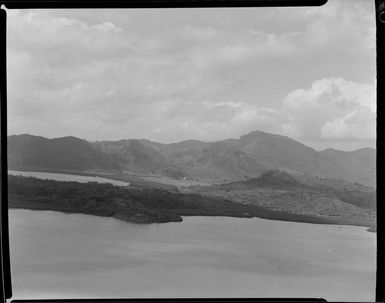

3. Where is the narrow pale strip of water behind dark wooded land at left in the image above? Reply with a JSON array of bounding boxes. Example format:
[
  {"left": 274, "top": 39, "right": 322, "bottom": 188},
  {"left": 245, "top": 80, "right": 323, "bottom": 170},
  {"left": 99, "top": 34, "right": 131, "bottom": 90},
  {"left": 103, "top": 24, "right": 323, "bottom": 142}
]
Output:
[{"left": 8, "top": 170, "right": 129, "bottom": 186}]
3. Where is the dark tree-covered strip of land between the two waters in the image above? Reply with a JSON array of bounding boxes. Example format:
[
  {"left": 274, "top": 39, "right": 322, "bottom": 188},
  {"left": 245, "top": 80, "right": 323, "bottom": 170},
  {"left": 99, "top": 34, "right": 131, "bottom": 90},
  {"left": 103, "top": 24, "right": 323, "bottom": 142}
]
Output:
[{"left": 8, "top": 175, "right": 352, "bottom": 224}]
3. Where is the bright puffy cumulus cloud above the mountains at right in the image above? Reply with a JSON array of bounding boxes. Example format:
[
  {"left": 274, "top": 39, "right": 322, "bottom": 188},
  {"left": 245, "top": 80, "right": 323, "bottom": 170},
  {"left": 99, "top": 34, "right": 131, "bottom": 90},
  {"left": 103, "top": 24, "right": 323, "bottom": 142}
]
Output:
[{"left": 282, "top": 78, "right": 376, "bottom": 141}]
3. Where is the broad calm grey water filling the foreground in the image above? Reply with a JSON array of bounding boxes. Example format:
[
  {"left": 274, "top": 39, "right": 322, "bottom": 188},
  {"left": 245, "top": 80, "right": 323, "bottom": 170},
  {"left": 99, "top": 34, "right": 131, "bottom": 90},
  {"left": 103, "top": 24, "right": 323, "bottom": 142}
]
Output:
[{"left": 10, "top": 210, "right": 375, "bottom": 301}]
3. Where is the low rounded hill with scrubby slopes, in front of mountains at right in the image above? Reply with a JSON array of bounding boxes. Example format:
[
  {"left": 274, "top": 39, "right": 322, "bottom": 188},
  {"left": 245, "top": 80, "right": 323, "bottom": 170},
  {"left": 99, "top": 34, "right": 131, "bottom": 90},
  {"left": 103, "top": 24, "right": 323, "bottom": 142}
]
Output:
[{"left": 184, "top": 170, "right": 376, "bottom": 229}]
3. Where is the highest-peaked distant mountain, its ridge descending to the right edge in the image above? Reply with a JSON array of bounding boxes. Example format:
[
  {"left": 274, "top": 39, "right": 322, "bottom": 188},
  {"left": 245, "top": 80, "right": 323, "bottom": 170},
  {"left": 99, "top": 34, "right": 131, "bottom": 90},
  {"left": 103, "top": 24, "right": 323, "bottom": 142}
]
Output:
[{"left": 228, "top": 131, "right": 376, "bottom": 186}]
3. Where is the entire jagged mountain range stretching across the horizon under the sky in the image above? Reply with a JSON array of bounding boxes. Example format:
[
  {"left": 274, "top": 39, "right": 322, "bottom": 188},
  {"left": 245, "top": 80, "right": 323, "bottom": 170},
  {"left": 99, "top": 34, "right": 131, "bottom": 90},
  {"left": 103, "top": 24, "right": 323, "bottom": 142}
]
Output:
[{"left": 8, "top": 131, "right": 376, "bottom": 187}]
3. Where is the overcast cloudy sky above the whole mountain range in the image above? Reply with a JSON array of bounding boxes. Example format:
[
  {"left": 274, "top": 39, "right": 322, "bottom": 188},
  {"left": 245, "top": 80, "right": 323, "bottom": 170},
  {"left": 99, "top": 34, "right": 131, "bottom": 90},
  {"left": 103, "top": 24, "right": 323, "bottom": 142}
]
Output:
[{"left": 7, "top": 0, "right": 376, "bottom": 150}]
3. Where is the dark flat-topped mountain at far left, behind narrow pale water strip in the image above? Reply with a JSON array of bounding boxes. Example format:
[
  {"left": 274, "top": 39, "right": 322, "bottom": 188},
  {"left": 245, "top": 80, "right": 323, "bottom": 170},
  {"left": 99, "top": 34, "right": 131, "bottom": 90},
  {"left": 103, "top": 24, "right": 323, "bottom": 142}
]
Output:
[{"left": 8, "top": 135, "right": 119, "bottom": 170}]
